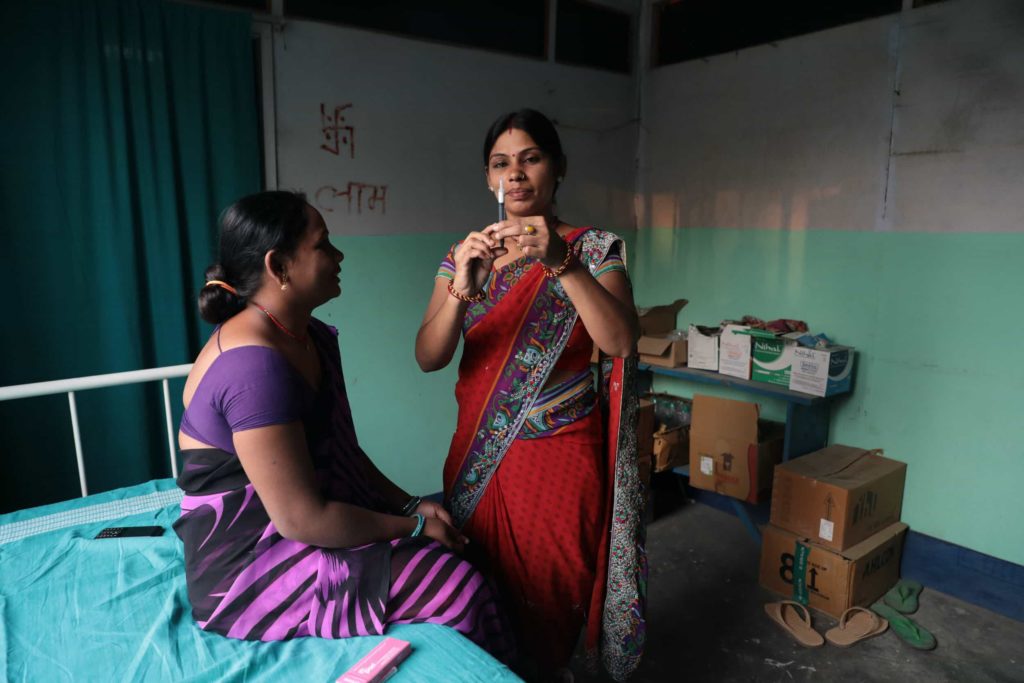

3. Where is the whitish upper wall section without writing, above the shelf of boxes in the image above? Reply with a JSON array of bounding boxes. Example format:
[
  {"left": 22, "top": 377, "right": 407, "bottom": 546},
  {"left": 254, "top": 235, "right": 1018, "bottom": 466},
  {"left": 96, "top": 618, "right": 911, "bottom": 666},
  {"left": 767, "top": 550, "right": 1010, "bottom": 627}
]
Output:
[{"left": 638, "top": 0, "right": 1024, "bottom": 231}]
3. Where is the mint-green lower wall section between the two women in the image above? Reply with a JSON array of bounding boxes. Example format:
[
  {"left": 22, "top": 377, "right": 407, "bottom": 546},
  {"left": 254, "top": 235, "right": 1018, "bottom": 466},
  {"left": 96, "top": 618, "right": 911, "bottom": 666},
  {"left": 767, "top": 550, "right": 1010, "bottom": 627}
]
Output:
[{"left": 315, "top": 233, "right": 465, "bottom": 494}]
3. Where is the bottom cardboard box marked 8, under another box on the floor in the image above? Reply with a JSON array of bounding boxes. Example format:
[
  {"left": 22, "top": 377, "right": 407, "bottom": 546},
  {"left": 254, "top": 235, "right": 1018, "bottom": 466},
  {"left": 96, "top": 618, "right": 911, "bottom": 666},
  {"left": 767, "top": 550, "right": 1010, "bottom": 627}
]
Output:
[{"left": 760, "top": 522, "right": 907, "bottom": 618}]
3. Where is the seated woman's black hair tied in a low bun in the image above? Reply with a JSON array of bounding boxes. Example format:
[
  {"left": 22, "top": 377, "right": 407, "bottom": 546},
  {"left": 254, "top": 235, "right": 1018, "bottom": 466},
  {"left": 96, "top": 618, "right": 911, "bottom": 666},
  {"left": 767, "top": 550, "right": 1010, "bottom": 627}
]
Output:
[{"left": 199, "top": 190, "right": 308, "bottom": 325}]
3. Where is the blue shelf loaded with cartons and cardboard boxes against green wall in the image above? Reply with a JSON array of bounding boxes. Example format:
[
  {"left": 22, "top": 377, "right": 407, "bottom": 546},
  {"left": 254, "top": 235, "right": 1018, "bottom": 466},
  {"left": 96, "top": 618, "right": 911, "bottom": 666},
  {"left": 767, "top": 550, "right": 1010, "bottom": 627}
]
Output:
[{"left": 638, "top": 307, "right": 854, "bottom": 540}]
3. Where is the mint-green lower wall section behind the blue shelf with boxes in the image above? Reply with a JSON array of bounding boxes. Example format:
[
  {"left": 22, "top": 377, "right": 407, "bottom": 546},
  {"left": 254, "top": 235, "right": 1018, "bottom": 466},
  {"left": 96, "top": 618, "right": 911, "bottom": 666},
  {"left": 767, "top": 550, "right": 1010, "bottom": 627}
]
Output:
[{"left": 631, "top": 228, "right": 1024, "bottom": 564}]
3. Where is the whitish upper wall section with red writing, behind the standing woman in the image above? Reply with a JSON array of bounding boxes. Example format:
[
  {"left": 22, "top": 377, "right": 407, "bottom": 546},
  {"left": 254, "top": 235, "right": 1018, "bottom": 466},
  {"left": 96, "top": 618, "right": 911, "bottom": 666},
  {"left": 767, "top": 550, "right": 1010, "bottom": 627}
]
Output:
[{"left": 274, "top": 22, "right": 636, "bottom": 234}]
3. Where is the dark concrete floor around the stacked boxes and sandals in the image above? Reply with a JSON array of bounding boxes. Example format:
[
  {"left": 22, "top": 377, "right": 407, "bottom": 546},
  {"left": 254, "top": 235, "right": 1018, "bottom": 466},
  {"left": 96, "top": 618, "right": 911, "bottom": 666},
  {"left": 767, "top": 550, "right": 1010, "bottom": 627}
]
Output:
[{"left": 572, "top": 479, "right": 1024, "bottom": 683}]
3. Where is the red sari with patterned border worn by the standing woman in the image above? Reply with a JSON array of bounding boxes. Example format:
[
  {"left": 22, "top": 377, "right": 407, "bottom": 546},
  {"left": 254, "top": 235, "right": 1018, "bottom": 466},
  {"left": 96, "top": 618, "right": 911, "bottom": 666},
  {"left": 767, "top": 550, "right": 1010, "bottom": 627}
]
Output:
[{"left": 444, "top": 228, "right": 646, "bottom": 679}]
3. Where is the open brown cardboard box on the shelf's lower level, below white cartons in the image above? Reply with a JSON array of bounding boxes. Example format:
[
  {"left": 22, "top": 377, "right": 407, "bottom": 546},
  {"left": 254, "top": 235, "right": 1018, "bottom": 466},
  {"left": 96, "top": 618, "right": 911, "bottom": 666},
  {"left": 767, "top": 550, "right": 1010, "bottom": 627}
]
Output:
[{"left": 690, "top": 395, "right": 785, "bottom": 503}]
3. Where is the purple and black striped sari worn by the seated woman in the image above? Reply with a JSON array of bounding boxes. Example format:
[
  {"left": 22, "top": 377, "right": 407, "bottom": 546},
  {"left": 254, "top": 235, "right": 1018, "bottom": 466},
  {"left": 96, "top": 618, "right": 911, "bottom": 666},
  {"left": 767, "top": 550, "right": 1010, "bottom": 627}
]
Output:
[{"left": 174, "top": 319, "right": 513, "bottom": 660}]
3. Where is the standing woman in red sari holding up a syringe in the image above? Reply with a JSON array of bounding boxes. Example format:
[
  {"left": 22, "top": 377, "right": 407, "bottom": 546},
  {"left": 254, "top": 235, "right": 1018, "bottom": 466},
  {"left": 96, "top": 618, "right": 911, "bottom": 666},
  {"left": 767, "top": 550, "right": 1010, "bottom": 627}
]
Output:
[{"left": 416, "top": 110, "right": 646, "bottom": 680}]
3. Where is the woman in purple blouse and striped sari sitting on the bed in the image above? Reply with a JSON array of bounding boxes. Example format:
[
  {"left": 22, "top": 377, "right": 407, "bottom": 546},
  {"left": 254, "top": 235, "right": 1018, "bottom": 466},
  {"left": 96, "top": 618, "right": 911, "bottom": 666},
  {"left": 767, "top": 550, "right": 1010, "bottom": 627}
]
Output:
[{"left": 174, "top": 191, "right": 512, "bottom": 659}]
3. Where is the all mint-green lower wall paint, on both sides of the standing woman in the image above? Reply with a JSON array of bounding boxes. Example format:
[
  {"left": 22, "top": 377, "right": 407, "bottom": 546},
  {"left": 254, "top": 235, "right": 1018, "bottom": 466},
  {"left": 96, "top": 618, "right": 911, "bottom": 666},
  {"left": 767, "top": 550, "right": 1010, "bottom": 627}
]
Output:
[{"left": 318, "top": 228, "right": 1024, "bottom": 564}]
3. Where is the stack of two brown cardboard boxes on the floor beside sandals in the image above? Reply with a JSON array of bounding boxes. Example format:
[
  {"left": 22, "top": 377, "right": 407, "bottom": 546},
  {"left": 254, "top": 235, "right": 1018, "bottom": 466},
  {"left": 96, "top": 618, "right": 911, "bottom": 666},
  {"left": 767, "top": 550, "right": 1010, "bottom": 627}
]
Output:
[{"left": 761, "top": 444, "right": 907, "bottom": 617}]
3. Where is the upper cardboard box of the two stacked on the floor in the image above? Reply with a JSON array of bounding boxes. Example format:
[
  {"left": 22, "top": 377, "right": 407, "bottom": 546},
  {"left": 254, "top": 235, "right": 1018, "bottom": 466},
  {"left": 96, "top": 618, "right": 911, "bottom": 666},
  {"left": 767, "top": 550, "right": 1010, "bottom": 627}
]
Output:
[{"left": 771, "top": 444, "right": 906, "bottom": 551}]
